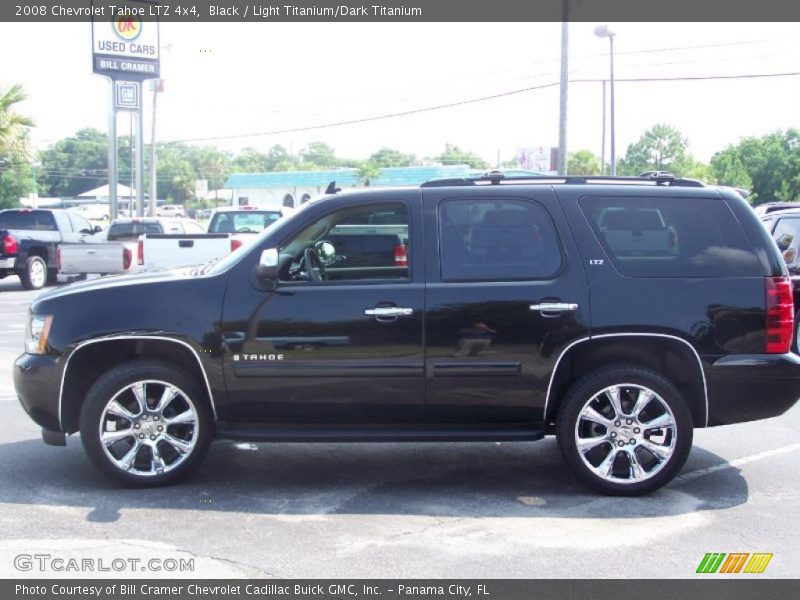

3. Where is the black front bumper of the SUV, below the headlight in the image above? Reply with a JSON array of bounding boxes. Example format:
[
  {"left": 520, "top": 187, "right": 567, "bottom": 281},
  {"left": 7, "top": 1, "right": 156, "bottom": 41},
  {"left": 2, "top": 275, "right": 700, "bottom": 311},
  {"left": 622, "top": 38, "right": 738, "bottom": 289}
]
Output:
[{"left": 14, "top": 354, "right": 61, "bottom": 431}]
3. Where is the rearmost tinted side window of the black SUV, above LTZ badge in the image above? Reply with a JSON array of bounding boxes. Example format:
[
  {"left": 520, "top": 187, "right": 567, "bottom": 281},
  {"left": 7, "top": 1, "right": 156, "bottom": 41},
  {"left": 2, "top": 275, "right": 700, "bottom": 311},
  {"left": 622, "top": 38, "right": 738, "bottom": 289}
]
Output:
[{"left": 579, "top": 197, "right": 764, "bottom": 277}]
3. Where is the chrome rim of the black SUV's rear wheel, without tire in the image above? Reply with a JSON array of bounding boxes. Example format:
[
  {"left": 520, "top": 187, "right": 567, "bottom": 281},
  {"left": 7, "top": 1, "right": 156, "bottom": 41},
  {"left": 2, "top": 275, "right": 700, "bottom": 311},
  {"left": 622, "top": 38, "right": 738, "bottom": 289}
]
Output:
[{"left": 575, "top": 383, "right": 678, "bottom": 484}]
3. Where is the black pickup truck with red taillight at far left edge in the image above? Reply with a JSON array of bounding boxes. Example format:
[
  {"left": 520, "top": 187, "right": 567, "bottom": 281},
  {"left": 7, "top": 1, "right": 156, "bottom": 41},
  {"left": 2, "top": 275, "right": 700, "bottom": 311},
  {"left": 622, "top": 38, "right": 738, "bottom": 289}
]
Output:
[{"left": 0, "top": 208, "right": 100, "bottom": 290}]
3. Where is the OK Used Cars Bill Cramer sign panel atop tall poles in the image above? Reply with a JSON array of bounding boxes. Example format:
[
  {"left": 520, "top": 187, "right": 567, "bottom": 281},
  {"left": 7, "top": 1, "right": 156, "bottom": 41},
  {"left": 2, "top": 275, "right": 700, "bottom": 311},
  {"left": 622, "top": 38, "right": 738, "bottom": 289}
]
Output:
[{"left": 92, "top": 0, "right": 160, "bottom": 80}]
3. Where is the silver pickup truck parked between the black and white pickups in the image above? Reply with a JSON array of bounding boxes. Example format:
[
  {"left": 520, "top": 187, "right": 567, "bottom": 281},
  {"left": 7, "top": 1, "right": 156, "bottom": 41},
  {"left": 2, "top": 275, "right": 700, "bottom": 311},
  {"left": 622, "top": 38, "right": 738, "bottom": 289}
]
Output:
[{"left": 57, "top": 217, "right": 210, "bottom": 275}]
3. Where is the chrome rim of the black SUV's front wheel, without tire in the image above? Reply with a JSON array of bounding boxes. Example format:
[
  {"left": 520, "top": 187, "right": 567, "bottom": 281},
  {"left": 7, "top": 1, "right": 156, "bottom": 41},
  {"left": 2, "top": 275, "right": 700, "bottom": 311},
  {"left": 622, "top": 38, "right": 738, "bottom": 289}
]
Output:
[{"left": 100, "top": 380, "right": 199, "bottom": 477}]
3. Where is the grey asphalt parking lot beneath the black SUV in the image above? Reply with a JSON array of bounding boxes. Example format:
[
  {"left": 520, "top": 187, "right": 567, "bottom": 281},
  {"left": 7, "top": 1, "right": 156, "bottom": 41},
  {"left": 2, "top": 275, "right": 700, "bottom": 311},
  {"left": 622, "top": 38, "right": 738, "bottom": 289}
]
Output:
[{"left": 0, "top": 277, "right": 800, "bottom": 578}]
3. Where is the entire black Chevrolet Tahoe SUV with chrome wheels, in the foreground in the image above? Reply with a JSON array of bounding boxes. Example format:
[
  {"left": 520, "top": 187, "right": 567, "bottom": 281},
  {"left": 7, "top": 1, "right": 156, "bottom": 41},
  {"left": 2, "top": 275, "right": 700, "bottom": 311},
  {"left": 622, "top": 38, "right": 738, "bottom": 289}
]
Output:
[{"left": 14, "top": 174, "right": 800, "bottom": 495}]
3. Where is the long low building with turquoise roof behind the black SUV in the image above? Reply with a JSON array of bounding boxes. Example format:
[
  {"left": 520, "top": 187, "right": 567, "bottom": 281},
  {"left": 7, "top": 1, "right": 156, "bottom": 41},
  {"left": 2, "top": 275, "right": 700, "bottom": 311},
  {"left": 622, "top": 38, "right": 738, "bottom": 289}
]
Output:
[{"left": 225, "top": 165, "right": 475, "bottom": 209}]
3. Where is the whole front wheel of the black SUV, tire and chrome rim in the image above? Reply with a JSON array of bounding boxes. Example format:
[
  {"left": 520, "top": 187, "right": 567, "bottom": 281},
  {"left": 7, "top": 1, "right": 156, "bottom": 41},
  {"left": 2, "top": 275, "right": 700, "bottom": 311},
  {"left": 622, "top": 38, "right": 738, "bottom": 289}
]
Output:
[{"left": 80, "top": 360, "right": 211, "bottom": 486}]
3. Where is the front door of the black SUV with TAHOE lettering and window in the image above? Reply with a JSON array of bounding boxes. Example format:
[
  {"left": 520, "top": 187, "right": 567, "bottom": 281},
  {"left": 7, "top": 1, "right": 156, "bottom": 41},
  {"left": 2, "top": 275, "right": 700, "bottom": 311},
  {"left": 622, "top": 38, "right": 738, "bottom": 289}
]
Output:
[{"left": 222, "top": 190, "right": 425, "bottom": 425}]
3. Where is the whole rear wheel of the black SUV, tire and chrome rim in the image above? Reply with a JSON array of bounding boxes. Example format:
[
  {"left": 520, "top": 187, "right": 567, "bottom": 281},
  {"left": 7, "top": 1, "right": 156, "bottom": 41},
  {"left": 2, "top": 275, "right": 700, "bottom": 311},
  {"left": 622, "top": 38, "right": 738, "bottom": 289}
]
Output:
[{"left": 556, "top": 365, "right": 692, "bottom": 496}]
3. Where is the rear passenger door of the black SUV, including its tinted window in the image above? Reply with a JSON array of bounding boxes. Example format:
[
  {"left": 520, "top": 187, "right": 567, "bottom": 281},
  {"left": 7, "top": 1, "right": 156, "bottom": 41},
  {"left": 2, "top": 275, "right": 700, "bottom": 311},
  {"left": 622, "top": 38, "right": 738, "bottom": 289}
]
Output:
[{"left": 424, "top": 187, "right": 589, "bottom": 423}]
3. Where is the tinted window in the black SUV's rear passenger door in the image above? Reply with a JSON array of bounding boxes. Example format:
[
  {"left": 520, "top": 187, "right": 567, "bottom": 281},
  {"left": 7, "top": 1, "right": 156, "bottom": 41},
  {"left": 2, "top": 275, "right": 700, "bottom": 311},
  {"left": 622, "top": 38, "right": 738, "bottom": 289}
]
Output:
[{"left": 439, "top": 199, "right": 561, "bottom": 281}]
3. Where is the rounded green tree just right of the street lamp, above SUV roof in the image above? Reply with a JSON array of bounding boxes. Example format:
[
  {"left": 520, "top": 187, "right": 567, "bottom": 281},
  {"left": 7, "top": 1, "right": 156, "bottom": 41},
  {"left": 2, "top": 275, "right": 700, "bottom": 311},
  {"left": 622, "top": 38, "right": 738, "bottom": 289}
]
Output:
[{"left": 617, "top": 124, "right": 689, "bottom": 177}]
